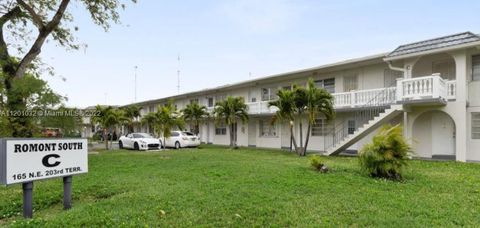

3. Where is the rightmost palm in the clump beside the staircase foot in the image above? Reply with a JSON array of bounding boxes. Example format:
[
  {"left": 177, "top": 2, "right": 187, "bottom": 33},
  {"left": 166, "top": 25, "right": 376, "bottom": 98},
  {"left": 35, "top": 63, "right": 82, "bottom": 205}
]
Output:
[{"left": 302, "top": 78, "right": 335, "bottom": 156}]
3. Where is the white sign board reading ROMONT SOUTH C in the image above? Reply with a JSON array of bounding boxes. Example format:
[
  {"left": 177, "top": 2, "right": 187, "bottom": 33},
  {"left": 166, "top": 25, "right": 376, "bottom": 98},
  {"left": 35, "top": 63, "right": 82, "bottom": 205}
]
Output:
[{"left": 0, "top": 139, "right": 88, "bottom": 185}]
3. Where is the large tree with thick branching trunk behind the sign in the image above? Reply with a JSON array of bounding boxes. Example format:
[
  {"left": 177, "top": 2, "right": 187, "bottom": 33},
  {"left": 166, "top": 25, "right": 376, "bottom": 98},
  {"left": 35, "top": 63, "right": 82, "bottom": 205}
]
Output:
[{"left": 0, "top": 0, "right": 136, "bottom": 137}]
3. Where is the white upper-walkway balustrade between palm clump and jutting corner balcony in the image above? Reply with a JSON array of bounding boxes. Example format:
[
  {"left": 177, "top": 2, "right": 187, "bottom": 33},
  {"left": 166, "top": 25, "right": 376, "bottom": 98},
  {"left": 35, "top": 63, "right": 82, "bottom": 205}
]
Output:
[{"left": 332, "top": 87, "right": 397, "bottom": 108}]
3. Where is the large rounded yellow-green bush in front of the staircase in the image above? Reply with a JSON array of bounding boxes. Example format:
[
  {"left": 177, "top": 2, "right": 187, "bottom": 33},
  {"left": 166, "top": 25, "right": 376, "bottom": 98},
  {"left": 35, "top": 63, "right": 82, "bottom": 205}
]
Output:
[{"left": 359, "top": 125, "right": 412, "bottom": 180}]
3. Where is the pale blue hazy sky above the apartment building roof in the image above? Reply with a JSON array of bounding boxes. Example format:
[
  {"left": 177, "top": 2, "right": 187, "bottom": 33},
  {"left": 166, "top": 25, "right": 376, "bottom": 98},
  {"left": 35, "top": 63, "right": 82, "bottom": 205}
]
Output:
[{"left": 40, "top": 0, "right": 480, "bottom": 107}]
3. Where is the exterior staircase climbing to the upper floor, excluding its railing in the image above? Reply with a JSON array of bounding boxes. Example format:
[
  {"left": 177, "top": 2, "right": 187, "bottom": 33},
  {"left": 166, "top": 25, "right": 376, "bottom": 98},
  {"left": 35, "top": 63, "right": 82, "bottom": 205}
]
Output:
[{"left": 324, "top": 105, "right": 403, "bottom": 156}]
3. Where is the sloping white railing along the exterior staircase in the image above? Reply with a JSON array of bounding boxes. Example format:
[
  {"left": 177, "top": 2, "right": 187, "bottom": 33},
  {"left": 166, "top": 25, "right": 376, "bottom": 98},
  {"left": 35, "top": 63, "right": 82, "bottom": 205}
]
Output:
[{"left": 323, "top": 82, "right": 397, "bottom": 152}]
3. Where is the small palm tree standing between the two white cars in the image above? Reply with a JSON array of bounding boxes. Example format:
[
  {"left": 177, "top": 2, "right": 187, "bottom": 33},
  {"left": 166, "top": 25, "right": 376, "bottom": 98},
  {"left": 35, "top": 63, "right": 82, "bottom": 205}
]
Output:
[{"left": 155, "top": 101, "right": 185, "bottom": 148}]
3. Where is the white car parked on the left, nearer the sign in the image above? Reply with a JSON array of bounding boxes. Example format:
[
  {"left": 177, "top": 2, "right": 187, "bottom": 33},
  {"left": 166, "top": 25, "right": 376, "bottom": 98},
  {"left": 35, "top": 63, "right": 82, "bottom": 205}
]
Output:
[{"left": 118, "top": 133, "right": 162, "bottom": 150}]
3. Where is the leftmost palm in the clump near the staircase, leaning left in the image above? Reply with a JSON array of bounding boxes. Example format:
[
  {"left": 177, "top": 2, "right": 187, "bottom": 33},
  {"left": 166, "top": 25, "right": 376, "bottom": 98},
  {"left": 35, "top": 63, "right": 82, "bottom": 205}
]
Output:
[{"left": 268, "top": 89, "right": 298, "bottom": 152}]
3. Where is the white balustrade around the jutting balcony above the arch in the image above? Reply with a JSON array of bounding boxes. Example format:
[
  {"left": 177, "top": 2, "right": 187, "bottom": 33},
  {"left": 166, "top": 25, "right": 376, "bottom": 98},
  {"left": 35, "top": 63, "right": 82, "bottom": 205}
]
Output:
[{"left": 397, "top": 74, "right": 456, "bottom": 101}]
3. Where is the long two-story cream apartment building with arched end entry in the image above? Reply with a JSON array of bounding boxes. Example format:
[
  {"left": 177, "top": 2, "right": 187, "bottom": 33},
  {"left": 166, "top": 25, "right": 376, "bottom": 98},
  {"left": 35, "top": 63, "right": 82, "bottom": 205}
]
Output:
[{"left": 120, "top": 32, "right": 480, "bottom": 161}]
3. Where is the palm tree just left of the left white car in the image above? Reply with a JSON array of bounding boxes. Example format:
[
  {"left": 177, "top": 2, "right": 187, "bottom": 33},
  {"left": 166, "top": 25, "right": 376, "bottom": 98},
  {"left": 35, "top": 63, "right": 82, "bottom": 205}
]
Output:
[{"left": 92, "top": 105, "right": 124, "bottom": 150}]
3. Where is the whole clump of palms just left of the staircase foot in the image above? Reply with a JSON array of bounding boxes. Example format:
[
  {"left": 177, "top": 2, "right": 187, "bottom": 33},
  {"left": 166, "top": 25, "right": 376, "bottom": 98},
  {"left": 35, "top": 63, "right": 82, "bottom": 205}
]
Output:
[{"left": 269, "top": 78, "right": 335, "bottom": 156}]
